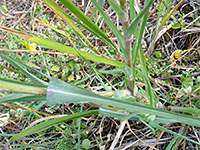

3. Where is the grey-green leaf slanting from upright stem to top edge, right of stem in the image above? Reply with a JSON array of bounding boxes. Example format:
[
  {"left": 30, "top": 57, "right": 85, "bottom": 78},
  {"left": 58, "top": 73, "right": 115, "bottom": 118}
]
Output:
[{"left": 127, "top": 0, "right": 154, "bottom": 39}]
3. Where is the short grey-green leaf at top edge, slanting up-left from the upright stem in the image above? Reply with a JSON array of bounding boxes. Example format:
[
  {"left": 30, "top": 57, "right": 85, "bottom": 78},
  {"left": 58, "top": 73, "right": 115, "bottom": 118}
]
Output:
[{"left": 108, "top": 0, "right": 126, "bottom": 20}]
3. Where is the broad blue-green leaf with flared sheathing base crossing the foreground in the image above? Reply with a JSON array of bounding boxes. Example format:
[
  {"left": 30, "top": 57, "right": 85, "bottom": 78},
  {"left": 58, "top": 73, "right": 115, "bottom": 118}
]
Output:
[{"left": 47, "top": 78, "right": 200, "bottom": 127}]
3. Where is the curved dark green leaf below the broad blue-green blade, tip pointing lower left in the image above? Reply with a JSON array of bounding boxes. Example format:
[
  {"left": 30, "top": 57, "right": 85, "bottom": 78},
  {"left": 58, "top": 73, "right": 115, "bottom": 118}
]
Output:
[{"left": 9, "top": 110, "right": 98, "bottom": 142}]
